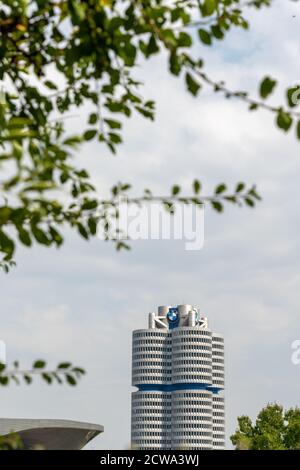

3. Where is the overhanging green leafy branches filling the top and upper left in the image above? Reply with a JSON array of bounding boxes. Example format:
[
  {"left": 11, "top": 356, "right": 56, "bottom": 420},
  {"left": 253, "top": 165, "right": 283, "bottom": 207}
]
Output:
[{"left": 0, "top": 0, "right": 300, "bottom": 271}]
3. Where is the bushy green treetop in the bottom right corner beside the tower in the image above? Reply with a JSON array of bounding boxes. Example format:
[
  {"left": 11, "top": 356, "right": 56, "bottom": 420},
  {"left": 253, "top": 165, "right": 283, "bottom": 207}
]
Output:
[{"left": 231, "top": 403, "right": 300, "bottom": 450}]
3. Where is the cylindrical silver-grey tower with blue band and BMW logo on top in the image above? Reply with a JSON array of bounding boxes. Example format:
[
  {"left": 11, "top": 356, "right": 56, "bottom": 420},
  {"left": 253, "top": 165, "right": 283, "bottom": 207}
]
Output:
[{"left": 131, "top": 305, "right": 225, "bottom": 450}]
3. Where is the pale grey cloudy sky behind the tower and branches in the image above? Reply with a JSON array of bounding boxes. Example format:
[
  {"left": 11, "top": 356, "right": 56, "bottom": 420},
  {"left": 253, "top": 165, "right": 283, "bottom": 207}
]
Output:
[{"left": 0, "top": 0, "right": 300, "bottom": 449}]
